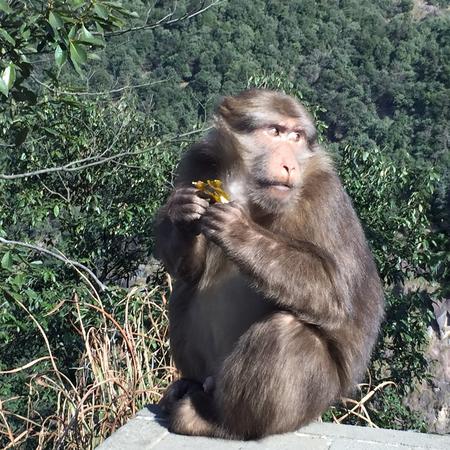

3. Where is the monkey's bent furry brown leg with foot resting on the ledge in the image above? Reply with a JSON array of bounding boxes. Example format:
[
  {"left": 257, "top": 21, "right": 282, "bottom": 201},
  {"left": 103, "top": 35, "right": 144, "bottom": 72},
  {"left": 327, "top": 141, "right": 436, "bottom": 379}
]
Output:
[{"left": 171, "top": 312, "right": 340, "bottom": 439}]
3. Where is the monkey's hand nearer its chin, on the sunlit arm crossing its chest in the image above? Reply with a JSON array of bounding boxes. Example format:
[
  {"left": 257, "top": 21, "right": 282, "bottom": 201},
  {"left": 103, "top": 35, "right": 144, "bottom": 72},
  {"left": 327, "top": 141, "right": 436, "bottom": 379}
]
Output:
[{"left": 200, "top": 202, "right": 252, "bottom": 254}]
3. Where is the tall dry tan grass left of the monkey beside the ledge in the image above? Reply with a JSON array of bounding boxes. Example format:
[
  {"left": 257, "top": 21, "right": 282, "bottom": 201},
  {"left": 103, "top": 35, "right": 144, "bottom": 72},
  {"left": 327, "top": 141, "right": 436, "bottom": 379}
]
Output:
[{"left": 0, "top": 280, "right": 175, "bottom": 450}]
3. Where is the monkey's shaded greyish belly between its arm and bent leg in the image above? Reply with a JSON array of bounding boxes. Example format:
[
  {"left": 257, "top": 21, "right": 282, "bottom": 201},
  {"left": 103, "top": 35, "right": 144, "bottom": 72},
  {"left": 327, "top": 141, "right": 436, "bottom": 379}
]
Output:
[{"left": 177, "top": 273, "right": 273, "bottom": 379}]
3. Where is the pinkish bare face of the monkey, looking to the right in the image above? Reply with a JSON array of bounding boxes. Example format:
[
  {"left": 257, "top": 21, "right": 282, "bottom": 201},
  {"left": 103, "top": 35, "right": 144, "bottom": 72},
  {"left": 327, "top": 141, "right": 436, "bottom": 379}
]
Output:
[{"left": 244, "top": 118, "right": 313, "bottom": 213}]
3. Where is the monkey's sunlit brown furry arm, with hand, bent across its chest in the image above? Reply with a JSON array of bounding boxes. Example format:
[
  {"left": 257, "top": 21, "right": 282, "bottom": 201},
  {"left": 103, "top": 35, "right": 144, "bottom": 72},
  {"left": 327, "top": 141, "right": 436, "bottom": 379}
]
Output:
[{"left": 202, "top": 203, "right": 349, "bottom": 325}]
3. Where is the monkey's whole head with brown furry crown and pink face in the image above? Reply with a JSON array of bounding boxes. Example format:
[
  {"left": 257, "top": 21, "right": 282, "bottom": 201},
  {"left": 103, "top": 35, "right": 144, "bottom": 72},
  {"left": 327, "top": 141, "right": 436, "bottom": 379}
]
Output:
[{"left": 216, "top": 89, "right": 320, "bottom": 213}]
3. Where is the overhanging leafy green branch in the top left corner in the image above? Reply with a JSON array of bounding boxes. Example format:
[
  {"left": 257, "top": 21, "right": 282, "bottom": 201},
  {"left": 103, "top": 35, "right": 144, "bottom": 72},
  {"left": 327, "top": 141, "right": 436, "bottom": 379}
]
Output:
[{"left": 0, "top": 0, "right": 136, "bottom": 101}]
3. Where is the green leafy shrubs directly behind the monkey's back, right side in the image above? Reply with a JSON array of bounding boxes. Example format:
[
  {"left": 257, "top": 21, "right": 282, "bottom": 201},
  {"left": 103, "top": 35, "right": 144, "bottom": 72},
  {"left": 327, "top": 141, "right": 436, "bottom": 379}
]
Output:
[{"left": 340, "top": 146, "right": 445, "bottom": 431}]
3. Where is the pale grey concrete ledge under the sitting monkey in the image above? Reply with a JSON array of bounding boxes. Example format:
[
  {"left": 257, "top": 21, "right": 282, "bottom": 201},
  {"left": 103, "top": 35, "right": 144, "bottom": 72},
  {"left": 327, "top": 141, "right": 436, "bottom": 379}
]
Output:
[{"left": 97, "top": 405, "right": 450, "bottom": 450}]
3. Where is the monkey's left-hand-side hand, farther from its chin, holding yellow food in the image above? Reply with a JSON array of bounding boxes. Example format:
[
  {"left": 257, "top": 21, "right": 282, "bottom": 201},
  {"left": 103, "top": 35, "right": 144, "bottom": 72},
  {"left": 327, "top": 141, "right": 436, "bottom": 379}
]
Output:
[{"left": 167, "top": 187, "right": 209, "bottom": 234}]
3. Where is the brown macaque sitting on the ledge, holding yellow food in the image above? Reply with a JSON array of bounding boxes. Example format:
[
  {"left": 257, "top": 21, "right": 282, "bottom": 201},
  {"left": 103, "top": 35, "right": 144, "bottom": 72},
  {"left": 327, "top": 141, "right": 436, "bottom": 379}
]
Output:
[{"left": 157, "top": 90, "right": 384, "bottom": 439}]
